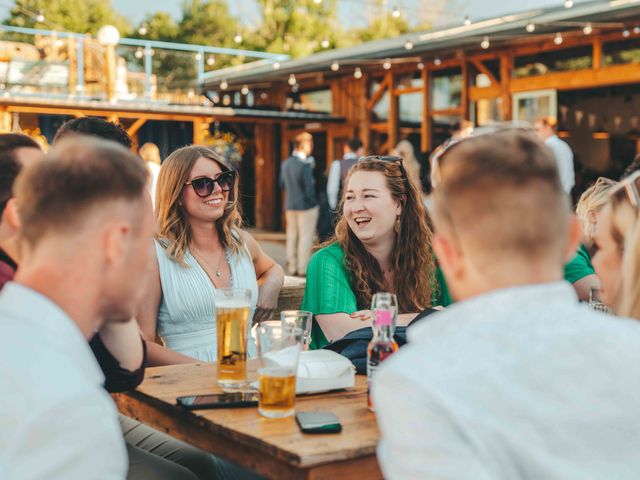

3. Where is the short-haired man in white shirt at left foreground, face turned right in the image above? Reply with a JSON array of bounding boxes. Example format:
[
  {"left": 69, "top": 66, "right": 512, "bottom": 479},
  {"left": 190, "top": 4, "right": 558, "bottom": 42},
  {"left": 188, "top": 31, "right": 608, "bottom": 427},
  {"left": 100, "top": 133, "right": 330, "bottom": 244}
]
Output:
[{"left": 0, "top": 137, "right": 155, "bottom": 479}]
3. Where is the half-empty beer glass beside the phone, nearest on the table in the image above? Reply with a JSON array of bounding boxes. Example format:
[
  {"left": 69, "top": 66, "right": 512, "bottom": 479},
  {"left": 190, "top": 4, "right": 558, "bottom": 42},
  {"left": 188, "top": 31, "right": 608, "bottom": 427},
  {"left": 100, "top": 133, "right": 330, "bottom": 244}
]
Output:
[{"left": 257, "top": 324, "right": 303, "bottom": 418}]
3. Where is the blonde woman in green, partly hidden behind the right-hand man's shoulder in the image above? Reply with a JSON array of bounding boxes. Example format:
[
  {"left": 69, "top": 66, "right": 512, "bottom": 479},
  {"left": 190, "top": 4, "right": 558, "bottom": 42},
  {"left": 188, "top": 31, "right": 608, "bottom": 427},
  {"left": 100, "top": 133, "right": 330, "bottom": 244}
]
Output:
[{"left": 564, "top": 177, "right": 616, "bottom": 301}]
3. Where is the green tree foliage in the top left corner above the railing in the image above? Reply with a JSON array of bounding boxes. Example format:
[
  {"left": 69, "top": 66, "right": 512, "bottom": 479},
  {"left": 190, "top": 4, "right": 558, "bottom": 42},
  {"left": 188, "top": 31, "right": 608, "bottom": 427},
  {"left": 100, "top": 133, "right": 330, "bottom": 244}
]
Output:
[{"left": 4, "top": 0, "right": 131, "bottom": 36}]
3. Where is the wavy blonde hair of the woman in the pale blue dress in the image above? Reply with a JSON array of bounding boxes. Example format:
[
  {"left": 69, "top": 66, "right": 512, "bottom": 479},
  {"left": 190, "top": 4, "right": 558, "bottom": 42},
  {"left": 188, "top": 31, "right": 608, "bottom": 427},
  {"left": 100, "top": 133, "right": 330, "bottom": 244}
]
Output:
[{"left": 156, "top": 145, "right": 242, "bottom": 265}]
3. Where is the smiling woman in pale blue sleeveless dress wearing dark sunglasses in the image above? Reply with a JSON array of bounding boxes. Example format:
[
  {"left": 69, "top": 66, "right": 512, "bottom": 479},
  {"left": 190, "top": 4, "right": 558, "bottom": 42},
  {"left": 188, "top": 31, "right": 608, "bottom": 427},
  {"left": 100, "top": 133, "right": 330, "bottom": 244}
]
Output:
[{"left": 139, "top": 145, "right": 284, "bottom": 365}]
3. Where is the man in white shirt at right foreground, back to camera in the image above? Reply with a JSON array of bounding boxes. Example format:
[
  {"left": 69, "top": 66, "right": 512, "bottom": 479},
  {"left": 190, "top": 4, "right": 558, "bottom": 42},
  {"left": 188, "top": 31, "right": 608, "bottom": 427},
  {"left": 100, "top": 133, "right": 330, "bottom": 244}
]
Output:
[{"left": 373, "top": 131, "right": 640, "bottom": 480}]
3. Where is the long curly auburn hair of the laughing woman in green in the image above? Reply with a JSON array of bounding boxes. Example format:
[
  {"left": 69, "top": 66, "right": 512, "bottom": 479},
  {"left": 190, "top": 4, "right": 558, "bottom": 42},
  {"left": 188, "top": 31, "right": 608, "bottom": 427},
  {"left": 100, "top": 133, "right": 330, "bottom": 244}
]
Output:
[{"left": 329, "top": 160, "right": 435, "bottom": 313}]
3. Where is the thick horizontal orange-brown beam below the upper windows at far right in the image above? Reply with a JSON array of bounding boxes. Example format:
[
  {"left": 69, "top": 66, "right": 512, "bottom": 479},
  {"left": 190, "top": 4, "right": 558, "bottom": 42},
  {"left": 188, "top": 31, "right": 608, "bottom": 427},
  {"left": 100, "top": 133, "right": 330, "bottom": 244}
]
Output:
[{"left": 510, "top": 64, "right": 640, "bottom": 92}]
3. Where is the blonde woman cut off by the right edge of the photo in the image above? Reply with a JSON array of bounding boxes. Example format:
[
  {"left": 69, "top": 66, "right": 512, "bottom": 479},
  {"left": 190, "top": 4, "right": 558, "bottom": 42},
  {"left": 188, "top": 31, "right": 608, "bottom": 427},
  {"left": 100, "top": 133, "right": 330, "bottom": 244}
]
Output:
[{"left": 593, "top": 172, "right": 640, "bottom": 320}]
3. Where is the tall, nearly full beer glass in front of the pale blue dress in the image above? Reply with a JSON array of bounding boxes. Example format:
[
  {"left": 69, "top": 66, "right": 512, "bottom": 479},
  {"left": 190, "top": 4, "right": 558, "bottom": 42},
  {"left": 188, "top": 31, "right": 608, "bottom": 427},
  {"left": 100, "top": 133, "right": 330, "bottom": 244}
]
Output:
[{"left": 215, "top": 288, "right": 251, "bottom": 388}]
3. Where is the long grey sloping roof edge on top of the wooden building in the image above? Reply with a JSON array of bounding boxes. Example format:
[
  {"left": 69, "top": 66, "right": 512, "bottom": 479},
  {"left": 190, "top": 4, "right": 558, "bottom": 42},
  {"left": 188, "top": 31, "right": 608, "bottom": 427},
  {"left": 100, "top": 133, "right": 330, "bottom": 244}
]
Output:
[{"left": 204, "top": 0, "right": 640, "bottom": 90}]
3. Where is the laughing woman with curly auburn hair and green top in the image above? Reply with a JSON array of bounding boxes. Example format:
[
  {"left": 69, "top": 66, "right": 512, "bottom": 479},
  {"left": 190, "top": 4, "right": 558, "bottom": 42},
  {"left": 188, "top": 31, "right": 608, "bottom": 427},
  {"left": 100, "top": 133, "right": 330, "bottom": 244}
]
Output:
[{"left": 302, "top": 157, "right": 444, "bottom": 348}]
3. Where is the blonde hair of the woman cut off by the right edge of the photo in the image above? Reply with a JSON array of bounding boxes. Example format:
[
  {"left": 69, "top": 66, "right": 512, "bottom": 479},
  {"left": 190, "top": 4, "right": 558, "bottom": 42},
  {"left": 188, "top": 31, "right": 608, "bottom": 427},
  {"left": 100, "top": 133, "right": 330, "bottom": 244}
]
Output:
[{"left": 610, "top": 172, "right": 640, "bottom": 320}]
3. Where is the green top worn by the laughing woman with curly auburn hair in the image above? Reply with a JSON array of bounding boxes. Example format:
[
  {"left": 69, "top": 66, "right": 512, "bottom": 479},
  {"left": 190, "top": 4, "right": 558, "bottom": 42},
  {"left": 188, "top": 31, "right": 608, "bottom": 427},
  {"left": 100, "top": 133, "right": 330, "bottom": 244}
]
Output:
[{"left": 301, "top": 243, "right": 452, "bottom": 349}]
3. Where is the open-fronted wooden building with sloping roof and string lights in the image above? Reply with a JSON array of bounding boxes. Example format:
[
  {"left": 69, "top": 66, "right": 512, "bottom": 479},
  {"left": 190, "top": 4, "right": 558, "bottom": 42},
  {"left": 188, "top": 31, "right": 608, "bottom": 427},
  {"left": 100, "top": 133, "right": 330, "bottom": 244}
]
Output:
[{"left": 204, "top": 0, "right": 640, "bottom": 229}]
